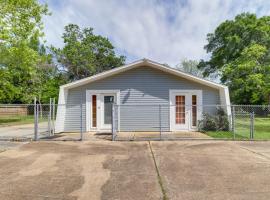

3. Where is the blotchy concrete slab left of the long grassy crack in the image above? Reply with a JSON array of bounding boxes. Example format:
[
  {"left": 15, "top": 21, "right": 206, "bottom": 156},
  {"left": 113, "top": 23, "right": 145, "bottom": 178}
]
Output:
[{"left": 0, "top": 142, "right": 162, "bottom": 200}]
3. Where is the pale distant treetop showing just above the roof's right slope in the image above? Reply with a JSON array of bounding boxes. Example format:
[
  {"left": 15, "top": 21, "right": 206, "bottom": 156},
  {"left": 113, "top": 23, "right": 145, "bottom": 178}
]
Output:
[{"left": 176, "top": 59, "right": 203, "bottom": 77}]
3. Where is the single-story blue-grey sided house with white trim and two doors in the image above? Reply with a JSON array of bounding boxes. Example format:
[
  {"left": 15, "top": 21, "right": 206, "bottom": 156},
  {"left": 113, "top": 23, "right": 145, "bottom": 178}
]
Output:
[{"left": 55, "top": 59, "right": 231, "bottom": 132}]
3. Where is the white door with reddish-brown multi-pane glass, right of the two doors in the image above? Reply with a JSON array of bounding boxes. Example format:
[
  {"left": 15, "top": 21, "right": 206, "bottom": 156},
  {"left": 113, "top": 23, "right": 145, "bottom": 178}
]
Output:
[{"left": 171, "top": 93, "right": 190, "bottom": 131}]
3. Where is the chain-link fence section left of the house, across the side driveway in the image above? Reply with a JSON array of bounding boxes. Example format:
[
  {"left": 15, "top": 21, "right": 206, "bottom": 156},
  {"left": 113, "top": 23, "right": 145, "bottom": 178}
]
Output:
[{"left": 0, "top": 104, "right": 56, "bottom": 141}]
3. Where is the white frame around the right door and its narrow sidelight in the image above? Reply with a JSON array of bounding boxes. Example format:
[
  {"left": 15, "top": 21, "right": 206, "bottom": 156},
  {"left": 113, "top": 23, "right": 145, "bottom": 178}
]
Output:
[{"left": 169, "top": 89, "right": 202, "bottom": 131}]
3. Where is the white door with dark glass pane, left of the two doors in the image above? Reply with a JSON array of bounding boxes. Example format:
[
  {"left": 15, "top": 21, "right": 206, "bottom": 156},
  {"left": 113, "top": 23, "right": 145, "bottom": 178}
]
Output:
[{"left": 100, "top": 94, "right": 116, "bottom": 129}]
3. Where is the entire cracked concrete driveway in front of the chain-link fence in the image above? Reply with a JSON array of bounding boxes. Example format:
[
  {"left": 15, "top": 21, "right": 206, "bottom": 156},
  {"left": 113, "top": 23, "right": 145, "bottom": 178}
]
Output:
[{"left": 0, "top": 141, "right": 270, "bottom": 200}]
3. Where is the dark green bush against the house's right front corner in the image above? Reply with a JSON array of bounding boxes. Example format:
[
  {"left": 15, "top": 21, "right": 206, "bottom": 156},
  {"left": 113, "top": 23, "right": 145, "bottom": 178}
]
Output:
[{"left": 198, "top": 108, "right": 229, "bottom": 132}]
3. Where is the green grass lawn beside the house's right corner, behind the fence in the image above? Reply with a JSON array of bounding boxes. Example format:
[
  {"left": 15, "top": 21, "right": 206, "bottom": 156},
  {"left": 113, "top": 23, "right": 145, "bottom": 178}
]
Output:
[{"left": 206, "top": 117, "right": 270, "bottom": 140}]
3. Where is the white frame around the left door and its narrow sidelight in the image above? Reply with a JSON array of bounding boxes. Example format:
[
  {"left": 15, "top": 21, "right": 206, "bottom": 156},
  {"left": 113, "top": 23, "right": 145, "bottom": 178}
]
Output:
[{"left": 85, "top": 90, "right": 120, "bottom": 131}]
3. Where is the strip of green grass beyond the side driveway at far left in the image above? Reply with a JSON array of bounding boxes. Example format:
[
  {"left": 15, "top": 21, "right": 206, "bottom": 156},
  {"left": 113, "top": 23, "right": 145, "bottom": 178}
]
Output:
[{"left": 0, "top": 115, "right": 34, "bottom": 126}]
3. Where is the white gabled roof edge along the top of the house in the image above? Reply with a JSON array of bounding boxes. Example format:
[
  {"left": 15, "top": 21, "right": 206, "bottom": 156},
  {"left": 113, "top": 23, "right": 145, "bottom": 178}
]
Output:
[{"left": 61, "top": 58, "right": 227, "bottom": 89}]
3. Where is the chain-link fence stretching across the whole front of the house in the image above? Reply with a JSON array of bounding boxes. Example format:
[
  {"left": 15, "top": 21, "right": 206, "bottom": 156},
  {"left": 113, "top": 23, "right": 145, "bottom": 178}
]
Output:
[{"left": 0, "top": 102, "right": 270, "bottom": 140}]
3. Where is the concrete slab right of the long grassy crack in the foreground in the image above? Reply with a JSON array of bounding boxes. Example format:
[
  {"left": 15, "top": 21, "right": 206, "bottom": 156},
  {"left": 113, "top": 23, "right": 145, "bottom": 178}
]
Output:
[{"left": 151, "top": 141, "right": 270, "bottom": 200}]
